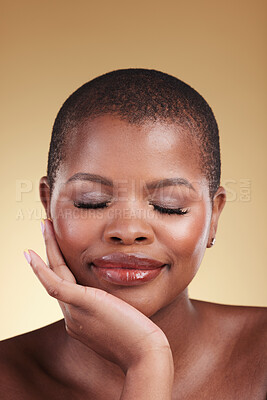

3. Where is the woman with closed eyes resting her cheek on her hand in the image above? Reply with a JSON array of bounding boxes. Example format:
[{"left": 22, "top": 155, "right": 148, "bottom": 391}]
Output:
[{"left": 1, "top": 69, "right": 267, "bottom": 400}]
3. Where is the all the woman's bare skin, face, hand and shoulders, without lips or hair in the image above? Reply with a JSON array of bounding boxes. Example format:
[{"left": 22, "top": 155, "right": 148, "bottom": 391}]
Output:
[{"left": 0, "top": 115, "right": 267, "bottom": 400}]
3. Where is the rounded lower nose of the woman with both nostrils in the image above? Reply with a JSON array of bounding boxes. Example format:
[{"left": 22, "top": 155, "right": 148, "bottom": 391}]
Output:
[{"left": 103, "top": 219, "right": 154, "bottom": 245}]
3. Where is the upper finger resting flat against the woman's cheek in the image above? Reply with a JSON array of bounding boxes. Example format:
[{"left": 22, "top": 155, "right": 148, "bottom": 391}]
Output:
[{"left": 41, "top": 219, "right": 76, "bottom": 282}]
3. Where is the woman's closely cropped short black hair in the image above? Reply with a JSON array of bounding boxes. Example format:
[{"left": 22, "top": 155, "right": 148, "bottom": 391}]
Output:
[{"left": 47, "top": 68, "right": 221, "bottom": 199}]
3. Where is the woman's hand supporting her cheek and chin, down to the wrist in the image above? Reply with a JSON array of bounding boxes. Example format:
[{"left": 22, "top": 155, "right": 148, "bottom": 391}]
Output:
[{"left": 24, "top": 219, "right": 172, "bottom": 373}]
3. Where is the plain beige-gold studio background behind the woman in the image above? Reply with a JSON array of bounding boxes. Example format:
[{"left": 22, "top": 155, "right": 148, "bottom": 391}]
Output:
[{"left": 0, "top": 0, "right": 267, "bottom": 339}]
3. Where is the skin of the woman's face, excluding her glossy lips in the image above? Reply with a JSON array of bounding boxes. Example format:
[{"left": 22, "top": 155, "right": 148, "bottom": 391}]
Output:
[{"left": 42, "top": 115, "right": 226, "bottom": 316}]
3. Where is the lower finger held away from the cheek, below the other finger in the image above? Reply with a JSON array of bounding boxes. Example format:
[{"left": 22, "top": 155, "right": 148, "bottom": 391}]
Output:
[{"left": 28, "top": 250, "right": 95, "bottom": 308}]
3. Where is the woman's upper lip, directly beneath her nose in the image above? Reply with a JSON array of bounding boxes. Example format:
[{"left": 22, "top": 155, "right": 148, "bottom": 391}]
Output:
[{"left": 92, "top": 252, "right": 168, "bottom": 269}]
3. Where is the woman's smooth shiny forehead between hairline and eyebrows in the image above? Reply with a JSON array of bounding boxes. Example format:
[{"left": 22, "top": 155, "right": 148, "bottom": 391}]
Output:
[{"left": 60, "top": 115, "right": 203, "bottom": 184}]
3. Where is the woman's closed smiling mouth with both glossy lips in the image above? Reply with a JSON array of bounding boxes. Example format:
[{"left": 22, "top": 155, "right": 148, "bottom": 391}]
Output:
[{"left": 91, "top": 253, "right": 169, "bottom": 286}]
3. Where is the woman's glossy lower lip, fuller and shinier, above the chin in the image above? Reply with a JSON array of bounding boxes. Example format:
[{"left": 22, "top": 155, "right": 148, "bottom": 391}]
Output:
[{"left": 92, "top": 265, "right": 166, "bottom": 286}]
